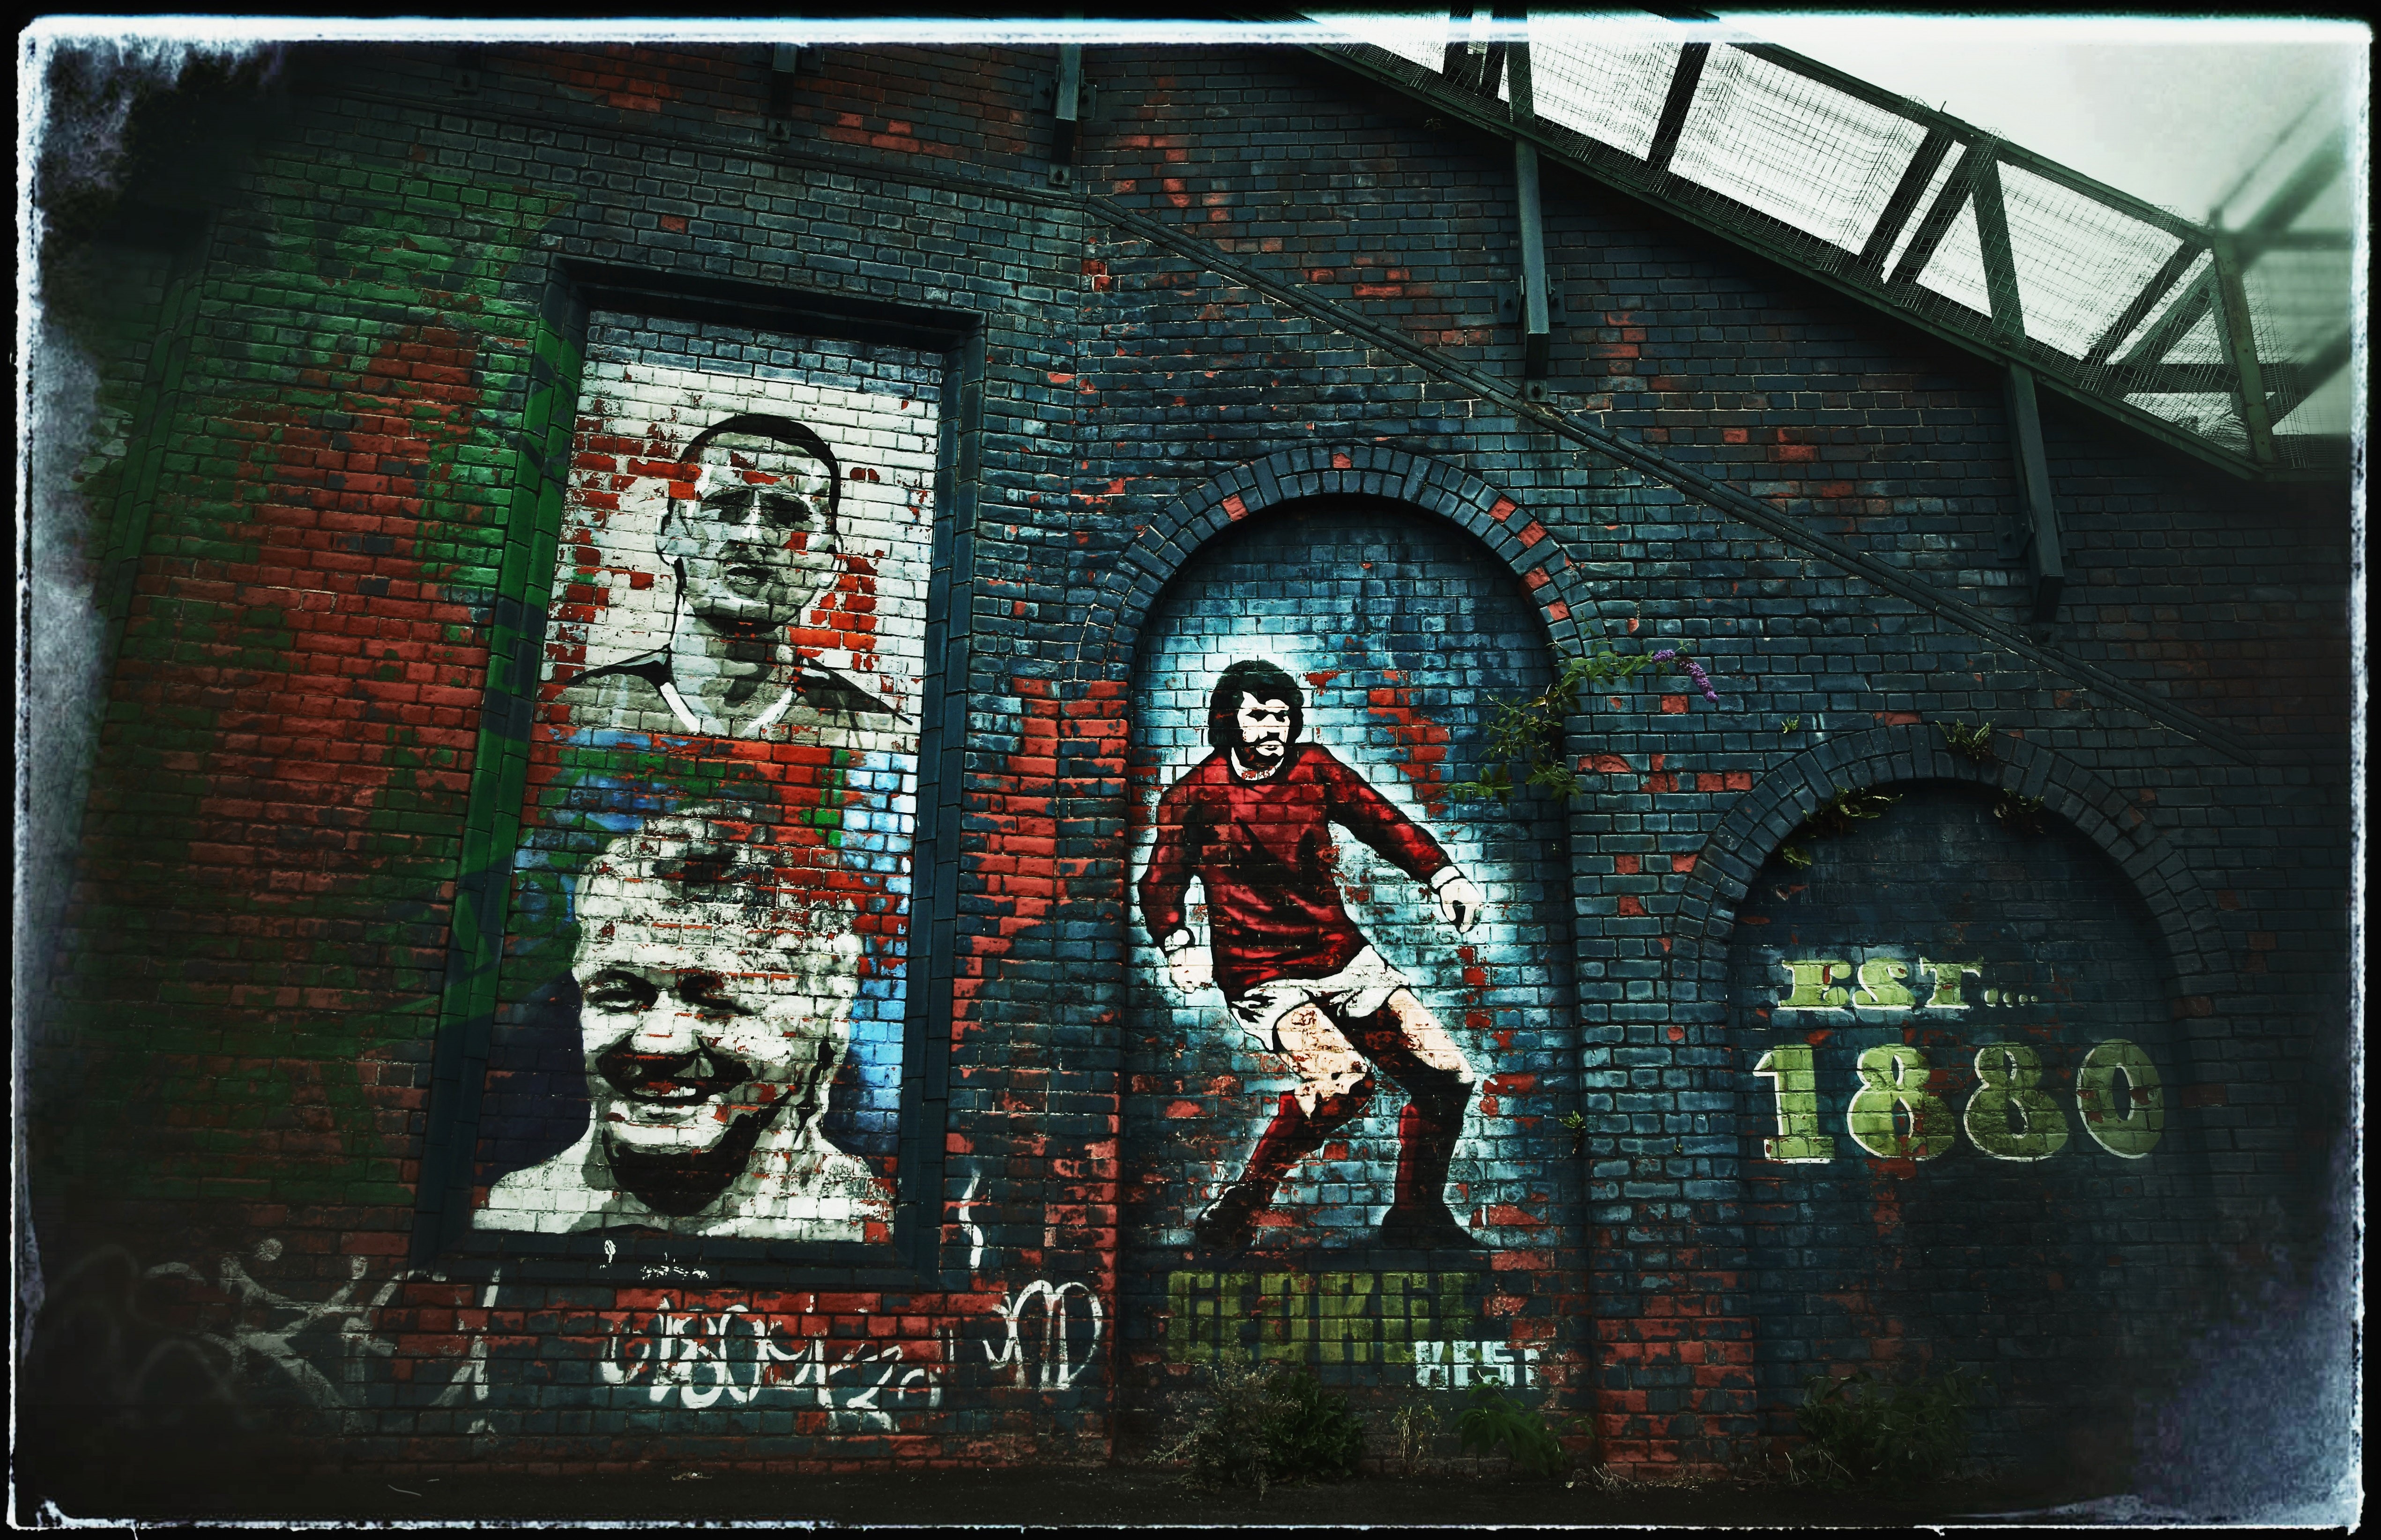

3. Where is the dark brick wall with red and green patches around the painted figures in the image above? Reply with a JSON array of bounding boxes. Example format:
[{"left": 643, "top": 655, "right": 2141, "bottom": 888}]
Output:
[{"left": 26, "top": 36, "right": 2348, "bottom": 1471}]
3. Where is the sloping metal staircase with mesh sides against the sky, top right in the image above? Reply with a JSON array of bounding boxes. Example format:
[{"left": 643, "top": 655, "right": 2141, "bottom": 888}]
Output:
[{"left": 1310, "top": 7, "right": 2352, "bottom": 481}]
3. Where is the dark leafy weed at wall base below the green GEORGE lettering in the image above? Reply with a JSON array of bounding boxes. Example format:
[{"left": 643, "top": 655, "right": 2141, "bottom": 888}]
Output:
[{"left": 1157, "top": 1347, "right": 1364, "bottom": 1497}]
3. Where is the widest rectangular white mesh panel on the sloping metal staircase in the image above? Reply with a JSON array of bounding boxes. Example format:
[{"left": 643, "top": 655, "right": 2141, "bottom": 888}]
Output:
[{"left": 1657, "top": 45, "right": 1926, "bottom": 250}]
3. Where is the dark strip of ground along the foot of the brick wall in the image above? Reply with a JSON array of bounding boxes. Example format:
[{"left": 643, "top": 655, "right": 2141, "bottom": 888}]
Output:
[{"left": 17, "top": 1466, "right": 2143, "bottom": 1528}]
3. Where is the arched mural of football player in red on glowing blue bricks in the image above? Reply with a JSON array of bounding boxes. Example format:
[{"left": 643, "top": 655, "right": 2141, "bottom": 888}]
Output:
[{"left": 1126, "top": 504, "right": 1574, "bottom": 1333}]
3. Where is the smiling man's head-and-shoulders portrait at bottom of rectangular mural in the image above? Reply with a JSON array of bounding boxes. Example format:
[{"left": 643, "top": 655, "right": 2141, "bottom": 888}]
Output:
[{"left": 476, "top": 807, "right": 888, "bottom": 1240}]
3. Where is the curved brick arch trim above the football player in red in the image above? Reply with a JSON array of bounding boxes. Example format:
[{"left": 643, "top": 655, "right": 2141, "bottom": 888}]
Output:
[{"left": 1064, "top": 443, "right": 1586, "bottom": 683}]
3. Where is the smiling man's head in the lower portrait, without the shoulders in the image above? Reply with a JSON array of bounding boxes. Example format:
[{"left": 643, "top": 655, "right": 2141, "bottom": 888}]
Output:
[{"left": 572, "top": 814, "right": 860, "bottom": 1214}]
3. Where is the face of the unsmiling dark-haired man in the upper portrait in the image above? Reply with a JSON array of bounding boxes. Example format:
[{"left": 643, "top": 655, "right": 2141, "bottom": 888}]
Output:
[{"left": 660, "top": 433, "right": 836, "bottom": 633}]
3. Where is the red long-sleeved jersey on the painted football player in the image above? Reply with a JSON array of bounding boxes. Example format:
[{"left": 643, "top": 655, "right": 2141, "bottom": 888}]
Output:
[{"left": 1140, "top": 743, "right": 1448, "bottom": 997}]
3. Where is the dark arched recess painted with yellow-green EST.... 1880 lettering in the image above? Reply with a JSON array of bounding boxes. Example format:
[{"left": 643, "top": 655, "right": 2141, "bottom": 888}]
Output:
[{"left": 1729, "top": 781, "right": 2205, "bottom": 1454}]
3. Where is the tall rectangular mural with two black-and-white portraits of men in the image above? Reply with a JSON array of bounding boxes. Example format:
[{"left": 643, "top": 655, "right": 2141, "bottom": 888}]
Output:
[{"left": 474, "top": 312, "right": 940, "bottom": 1243}]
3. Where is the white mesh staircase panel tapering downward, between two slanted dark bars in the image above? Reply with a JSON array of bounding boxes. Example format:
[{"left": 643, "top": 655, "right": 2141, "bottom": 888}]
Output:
[{"left": 2000, "top": 167, "right": 2183, "bottom": 359}]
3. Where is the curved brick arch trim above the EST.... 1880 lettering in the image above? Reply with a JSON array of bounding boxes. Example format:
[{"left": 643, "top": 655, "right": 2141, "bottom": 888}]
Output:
[{"left": 1669, "top": 724, "right": 2238, "bottom": 1036}]
